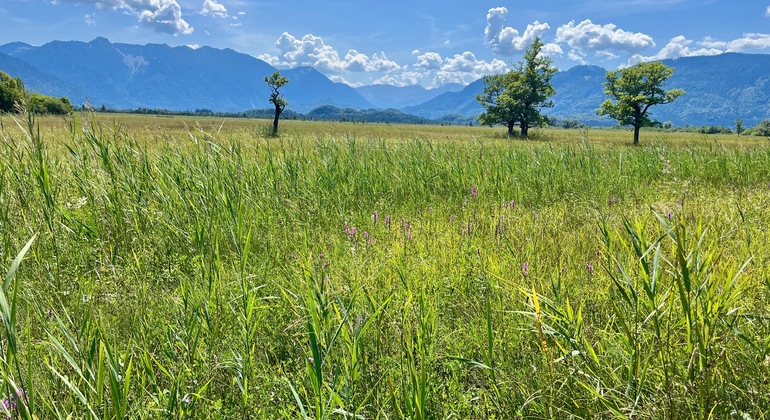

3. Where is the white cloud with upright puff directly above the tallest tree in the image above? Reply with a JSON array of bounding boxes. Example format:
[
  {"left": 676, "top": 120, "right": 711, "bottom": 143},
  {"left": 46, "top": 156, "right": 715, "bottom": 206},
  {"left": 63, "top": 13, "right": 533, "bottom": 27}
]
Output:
[{"left": 484, "top": 7, "right": 562, "bottom": 56}]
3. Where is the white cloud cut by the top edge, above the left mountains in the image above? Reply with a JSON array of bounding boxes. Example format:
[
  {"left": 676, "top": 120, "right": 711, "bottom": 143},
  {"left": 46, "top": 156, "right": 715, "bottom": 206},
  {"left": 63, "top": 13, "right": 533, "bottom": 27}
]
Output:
[{"left": 59, "top": 0, "right": 193, "bottom": 35}]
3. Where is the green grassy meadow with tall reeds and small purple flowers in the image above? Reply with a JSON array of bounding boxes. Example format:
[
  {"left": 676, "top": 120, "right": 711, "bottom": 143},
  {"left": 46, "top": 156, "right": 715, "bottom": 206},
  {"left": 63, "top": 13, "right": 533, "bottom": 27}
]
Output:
[{"left": 0, "top": 115, "right": 770, "bottom": 419}]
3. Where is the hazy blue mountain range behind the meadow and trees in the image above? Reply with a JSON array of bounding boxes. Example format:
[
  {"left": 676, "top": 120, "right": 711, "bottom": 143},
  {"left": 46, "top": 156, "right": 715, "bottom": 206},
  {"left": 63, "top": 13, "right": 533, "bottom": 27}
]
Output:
[{"left": 0, "top": 38, "right": 770, "bottom": 126}]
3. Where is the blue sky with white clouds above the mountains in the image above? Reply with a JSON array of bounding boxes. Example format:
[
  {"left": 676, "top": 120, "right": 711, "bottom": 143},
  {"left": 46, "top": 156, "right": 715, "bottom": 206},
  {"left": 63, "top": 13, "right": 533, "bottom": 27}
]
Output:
[{"left": 0, "top": 0, "right": 770, "bottom": 88}]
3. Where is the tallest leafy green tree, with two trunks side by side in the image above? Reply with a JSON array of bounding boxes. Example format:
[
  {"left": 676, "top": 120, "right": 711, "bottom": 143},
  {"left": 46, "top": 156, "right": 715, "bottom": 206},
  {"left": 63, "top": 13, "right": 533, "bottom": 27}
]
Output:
[{"left": 476, "top": 37, "right": 557, "bottom": 137}]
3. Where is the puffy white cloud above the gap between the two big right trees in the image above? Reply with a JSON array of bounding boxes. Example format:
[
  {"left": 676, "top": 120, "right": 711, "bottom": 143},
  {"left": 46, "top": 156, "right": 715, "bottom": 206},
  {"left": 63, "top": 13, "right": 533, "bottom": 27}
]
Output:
[{"left": 556, "top": 19, "right": 655, "bottom": 63}]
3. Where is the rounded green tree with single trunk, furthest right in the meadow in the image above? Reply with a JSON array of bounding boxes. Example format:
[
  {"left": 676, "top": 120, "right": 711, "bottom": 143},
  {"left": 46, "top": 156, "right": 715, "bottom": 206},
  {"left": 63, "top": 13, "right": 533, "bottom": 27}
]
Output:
[{"left": 596, "top": 62, "right": 684, "bottom": 144}]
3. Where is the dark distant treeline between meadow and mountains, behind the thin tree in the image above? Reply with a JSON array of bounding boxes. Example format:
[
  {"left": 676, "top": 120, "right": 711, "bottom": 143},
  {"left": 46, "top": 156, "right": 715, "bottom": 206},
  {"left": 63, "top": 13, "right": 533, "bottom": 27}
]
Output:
[{"left": 88, "top": 105, "right": 478, "bottom": 125}]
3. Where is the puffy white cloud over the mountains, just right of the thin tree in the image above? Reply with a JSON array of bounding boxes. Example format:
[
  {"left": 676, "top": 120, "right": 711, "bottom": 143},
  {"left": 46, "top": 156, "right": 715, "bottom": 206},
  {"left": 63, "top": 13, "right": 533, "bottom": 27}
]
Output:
[{"left": 259, "top": 32, "right": 401, "bottom": 74}]
